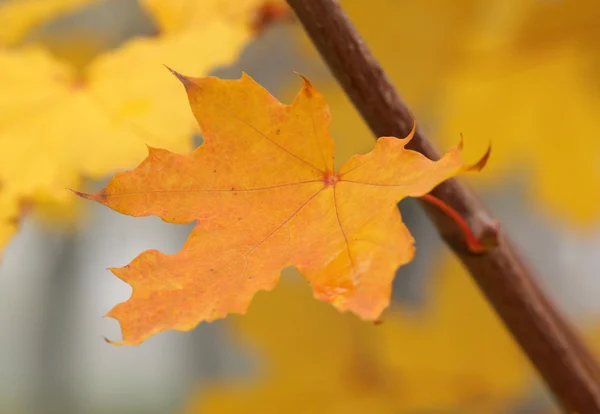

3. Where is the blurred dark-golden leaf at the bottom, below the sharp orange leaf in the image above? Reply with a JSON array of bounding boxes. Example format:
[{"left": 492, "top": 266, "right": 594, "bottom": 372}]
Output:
[{"left": 182, "top": 262, "right": 534, "bottom": 414}]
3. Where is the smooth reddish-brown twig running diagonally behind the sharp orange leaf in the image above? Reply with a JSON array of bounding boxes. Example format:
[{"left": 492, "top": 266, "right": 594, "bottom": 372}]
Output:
[{"left": 288, "top": 0, "right": 600, "bottom": 414}]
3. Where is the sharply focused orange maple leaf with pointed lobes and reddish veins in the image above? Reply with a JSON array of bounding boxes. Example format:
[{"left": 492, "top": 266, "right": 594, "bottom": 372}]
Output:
[{"left": 76, "top": 74, "right": 485, "bottom": 344}]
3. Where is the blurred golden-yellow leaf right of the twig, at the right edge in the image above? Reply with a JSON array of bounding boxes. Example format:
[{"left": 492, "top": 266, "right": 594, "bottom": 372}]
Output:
[{"left": 440, "top": 46, "right": 600, "bottom": 224}]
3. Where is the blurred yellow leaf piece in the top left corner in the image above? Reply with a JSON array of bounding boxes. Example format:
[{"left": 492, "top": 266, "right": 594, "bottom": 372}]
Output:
[{"left": 0, "top": 0, "right": 98, "bottom": 45}]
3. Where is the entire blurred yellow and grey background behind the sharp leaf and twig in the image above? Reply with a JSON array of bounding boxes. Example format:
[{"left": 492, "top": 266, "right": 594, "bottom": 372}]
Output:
[{"left": 0, "top": 0, "right": 600, "bottom": 414}]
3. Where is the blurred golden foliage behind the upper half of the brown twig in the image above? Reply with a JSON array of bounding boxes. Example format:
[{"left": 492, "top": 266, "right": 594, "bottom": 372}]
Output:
[{"left": 294, "top": 0, "right": 600, "bottom": 226}]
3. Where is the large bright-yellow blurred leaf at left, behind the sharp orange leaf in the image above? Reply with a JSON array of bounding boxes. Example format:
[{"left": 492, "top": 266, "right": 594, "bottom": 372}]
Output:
[{"left": 0, "top": 4, "right": 262, "bottom": 248}]
